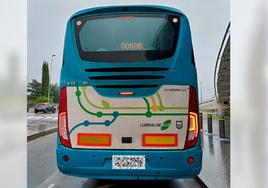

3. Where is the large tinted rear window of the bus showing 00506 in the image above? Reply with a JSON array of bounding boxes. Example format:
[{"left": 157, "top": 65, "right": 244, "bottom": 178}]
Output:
[{"left": 74, "top": 14, "right": 179, "bottom": 62}]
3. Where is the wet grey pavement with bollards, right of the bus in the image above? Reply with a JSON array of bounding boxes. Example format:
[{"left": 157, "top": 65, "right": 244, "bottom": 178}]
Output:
[{"left": 199, "top": 116, "right": 230, "bottom": 188}]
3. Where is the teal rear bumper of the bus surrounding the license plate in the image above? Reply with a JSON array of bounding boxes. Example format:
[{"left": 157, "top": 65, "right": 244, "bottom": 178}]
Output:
[{"left": 57, "top": 144, "right": 202, "bottom": 179}]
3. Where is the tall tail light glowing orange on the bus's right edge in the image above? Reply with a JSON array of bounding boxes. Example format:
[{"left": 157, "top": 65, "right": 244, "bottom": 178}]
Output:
[{"left": 184, "top": 86, "right": 199, "bottom": 149}]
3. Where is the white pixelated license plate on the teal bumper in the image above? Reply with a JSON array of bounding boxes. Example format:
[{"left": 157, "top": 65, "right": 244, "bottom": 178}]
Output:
[{"left": 112, "top": 155, "right": 145, "bottom": 170}]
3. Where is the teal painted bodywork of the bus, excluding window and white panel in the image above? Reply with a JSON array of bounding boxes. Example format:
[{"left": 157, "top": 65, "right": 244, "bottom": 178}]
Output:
[{"left": 56, "top": 6, "right": 202, "bottom": 179}]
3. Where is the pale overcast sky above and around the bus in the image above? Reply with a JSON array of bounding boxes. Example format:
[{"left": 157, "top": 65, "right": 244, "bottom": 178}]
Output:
[{"left": 27, "top": 0, "right": 230, "bottom": 100}]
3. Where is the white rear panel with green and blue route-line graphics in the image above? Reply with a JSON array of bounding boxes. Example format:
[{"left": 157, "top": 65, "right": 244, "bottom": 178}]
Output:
[{"left": 66, "top": 85, "right": 194, "bottom": 149}]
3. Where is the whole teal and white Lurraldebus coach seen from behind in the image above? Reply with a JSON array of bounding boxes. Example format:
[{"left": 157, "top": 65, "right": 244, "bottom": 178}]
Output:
[{"left": 56, "top": 6, "right": 202, "bottom": 180}]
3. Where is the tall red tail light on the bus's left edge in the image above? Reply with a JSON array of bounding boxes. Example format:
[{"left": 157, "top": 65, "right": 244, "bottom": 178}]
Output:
[{"left": 58, "top": 87, "right": 72, "bottom": 147}]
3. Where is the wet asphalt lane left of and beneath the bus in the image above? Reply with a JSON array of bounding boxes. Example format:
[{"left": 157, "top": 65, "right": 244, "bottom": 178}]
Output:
[{"left": 27, "top": 133, "right": 201, "bottom": 188}]
